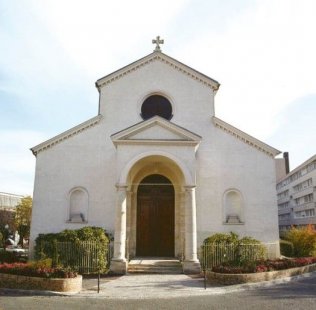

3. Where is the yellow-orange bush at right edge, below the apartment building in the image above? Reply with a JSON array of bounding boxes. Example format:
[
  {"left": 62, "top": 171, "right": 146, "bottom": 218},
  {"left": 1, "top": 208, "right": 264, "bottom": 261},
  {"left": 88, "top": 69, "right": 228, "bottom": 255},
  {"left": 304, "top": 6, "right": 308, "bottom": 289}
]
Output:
[{"left": 286, "top": 225, "right": 316, "bottom": 257}]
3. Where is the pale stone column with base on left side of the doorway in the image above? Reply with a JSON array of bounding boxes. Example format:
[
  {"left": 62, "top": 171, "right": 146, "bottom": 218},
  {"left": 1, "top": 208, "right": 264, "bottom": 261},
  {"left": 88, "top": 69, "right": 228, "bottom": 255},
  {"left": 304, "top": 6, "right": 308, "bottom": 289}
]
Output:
[{"left": 111, "top": 185, "right": 127, "bottom": 274}]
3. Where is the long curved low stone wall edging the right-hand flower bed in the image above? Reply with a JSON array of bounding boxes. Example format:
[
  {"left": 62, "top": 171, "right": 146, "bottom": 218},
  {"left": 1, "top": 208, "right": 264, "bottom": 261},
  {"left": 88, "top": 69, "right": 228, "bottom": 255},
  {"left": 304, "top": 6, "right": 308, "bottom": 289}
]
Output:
[{"left": 206, "top": 264, "right": 316, "bottom": 285}]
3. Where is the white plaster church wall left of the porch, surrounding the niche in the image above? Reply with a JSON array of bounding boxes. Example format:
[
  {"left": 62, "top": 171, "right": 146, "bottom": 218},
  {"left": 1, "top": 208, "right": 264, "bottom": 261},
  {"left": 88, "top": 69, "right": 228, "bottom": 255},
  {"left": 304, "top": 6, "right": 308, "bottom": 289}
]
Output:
[{"left": 31, "top": 121, "right": 116, "bottom": 252}]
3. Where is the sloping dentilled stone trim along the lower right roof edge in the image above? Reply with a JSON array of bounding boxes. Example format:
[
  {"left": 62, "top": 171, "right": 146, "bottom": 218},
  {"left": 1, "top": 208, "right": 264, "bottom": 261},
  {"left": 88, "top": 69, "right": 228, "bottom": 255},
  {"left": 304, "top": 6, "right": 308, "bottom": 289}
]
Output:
[{"left": 212, "top": 116, "right": 281, "bottom": 158}]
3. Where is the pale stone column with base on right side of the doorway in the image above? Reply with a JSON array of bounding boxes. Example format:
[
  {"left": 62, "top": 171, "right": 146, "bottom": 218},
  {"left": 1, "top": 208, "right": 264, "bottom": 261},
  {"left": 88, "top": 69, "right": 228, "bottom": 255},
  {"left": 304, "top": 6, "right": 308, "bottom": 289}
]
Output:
[{"left": 183, "top": 186, "right": 201, "bottom": 273}]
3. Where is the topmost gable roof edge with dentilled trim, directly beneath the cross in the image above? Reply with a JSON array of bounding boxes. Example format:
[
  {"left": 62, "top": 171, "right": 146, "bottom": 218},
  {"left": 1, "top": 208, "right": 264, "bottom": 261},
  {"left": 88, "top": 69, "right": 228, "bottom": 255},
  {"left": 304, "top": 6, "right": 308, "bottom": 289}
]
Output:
[{"left": 95, "top": 51, "right": 220, "bottom": 92}]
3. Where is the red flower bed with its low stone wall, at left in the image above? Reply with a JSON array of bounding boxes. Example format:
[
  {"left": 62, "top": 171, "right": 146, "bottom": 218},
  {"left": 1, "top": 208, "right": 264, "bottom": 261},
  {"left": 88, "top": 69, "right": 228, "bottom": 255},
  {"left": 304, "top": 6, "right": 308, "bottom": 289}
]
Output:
[{"left": 0, "top": 263, "right": 82, "bottom": 293}]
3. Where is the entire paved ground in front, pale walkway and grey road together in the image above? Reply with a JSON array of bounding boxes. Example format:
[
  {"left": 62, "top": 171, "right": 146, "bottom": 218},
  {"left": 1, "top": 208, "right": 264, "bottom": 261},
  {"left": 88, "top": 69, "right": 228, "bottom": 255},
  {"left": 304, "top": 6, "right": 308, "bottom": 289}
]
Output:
[{"left": 0, "top": 273, "right": 316, "bottom": 310}]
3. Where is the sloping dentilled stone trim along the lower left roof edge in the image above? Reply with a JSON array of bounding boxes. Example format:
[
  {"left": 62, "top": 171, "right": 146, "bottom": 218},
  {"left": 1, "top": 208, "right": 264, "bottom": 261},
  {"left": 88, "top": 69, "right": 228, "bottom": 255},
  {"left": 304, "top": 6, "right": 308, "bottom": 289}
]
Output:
[{"left": 31, "top": 114, "right": 102, "bottom": 156}]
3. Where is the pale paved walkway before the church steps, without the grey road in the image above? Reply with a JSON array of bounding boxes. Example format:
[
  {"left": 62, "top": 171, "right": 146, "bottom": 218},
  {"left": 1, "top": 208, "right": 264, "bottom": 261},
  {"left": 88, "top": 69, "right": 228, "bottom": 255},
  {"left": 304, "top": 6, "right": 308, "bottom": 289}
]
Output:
[{"left": 75, "top": 273, "right": 316, "bottom": 298}]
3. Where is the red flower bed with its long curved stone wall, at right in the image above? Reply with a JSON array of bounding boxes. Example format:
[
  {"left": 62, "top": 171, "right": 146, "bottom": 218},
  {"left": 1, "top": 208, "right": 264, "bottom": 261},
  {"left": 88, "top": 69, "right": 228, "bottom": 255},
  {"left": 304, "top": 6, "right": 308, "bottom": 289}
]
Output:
[{"left": 206, "top": 257, "right": 316, "bottom": 285}]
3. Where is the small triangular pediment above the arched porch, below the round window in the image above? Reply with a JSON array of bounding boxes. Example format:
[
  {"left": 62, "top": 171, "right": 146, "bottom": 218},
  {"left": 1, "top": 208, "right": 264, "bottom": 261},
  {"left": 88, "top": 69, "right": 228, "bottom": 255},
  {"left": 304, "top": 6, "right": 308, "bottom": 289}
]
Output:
[{"left": 111, "top": 116, "right": 201, "bottom": 145}]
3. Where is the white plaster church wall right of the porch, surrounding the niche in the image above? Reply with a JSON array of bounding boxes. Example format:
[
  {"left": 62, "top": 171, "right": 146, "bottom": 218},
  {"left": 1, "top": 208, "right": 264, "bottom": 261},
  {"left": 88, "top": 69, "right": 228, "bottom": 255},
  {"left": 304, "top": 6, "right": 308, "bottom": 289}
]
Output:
[{"left": 197, "top": 126, "right": 279, "bottom": 243}]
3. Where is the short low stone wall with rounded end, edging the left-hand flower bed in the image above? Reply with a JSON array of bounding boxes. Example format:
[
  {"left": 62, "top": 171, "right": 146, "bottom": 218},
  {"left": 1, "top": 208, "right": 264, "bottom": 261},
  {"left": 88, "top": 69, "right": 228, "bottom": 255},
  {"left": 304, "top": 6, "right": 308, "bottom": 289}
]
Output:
[{"left": 0, "top": 273, "right": 82, "bottom": 293}]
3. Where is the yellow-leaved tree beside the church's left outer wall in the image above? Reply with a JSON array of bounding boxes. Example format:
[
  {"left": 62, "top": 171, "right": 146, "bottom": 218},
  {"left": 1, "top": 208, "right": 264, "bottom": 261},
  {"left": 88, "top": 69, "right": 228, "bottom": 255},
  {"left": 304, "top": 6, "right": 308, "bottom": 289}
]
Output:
[{"left": 14, "top": 196, "right": 33, "bottom": 243}]
